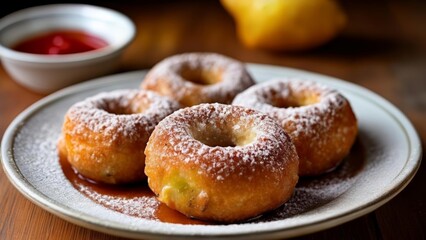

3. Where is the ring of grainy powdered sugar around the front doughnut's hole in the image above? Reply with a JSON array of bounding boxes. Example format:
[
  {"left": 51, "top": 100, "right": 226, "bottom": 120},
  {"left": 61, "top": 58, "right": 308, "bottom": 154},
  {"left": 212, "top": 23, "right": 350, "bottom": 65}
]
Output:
[{"left": 150, "top": 104, "right": 292, "bottom": 180}]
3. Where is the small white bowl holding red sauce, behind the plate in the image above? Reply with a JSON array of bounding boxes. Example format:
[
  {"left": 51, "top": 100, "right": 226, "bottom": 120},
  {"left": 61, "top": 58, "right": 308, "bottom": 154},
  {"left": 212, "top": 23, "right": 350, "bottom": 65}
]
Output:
[{"left": 0, "top": 4, "right": 136, "bottom": 93}]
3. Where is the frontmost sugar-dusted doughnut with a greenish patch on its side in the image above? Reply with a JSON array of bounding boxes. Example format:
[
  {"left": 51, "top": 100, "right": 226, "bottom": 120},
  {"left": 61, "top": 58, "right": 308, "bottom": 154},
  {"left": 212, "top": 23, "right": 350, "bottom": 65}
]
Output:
[{"left": 145, "top": 103, "right": 298, "bottom": 222}]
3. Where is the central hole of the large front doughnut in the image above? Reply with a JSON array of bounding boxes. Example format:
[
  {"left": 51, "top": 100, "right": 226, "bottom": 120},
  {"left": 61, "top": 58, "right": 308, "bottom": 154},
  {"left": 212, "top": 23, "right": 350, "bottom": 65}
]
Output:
[{"left": 190, "top": 122, "right": 256, "bottom": 147}]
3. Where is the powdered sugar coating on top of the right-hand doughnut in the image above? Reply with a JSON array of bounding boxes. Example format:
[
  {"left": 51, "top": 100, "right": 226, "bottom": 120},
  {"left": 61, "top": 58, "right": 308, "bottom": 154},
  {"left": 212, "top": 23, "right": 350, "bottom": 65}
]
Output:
[{"left": 232, "top": 78, "right": 345, "bottom": 140}]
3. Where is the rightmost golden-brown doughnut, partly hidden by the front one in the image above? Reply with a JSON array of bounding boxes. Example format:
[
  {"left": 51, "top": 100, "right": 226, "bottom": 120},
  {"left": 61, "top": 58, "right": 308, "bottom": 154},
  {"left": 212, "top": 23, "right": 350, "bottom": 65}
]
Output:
[{"left": 232, "top": 78, "right": 358, "bottom": 176}]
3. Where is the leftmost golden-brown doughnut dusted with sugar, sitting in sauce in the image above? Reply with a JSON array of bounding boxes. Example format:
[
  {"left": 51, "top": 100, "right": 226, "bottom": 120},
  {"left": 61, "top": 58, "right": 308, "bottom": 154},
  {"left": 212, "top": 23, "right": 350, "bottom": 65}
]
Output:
[{"left": 58, "top": 89, "right": 180, "bottom": 184}]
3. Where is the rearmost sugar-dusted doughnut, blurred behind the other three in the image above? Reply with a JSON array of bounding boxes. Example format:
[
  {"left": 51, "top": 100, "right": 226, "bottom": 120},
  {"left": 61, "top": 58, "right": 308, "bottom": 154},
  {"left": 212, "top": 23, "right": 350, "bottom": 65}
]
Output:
[{"left": 141, "top": 53, "right": 254, "bottom": 106}]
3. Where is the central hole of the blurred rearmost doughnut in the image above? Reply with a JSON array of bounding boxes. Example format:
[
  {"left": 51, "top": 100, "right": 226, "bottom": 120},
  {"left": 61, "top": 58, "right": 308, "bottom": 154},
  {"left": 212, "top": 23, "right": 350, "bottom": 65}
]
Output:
[{"left": 179, "top": 65, "right": 223, "bottom": 85}]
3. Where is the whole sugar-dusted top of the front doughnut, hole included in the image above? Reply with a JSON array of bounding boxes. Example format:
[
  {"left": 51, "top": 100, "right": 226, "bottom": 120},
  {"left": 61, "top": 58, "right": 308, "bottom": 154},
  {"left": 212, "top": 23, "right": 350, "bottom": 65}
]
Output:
[{"left": 148, "top": 104, "right": 297, "bottom": 180}]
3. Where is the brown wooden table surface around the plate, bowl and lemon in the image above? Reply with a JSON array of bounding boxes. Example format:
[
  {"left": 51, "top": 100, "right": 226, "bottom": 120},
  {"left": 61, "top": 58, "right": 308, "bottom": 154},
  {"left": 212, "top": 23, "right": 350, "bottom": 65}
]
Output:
[{"left": 0, "top": 0, "right": 426, "bottom": 240}]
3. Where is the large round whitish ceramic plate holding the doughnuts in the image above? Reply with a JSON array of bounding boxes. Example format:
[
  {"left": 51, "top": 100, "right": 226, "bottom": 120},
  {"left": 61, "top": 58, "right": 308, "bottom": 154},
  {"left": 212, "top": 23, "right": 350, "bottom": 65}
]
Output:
[{"left": 1, "top": 64, "right": 422, "bottom": 239}]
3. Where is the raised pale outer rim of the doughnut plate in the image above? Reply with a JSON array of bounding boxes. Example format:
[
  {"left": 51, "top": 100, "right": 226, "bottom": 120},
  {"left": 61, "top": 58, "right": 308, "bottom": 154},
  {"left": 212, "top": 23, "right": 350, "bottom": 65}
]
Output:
[{"left": 1, "top": 64, "right": 422, "bottom": 239}]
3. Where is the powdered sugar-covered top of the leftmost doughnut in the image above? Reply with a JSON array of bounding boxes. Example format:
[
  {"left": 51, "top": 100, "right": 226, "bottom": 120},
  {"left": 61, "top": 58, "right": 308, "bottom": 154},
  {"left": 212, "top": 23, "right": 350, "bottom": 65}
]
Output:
[{"left": 64, "top": 89, "right": 179, "bottom": 144}]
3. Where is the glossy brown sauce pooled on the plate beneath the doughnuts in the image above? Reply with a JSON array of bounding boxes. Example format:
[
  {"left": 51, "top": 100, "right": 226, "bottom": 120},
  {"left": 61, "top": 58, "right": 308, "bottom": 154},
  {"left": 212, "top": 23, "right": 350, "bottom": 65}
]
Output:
[{"left": 59, "top": 140, "right": 365, "bottom": 225}]
